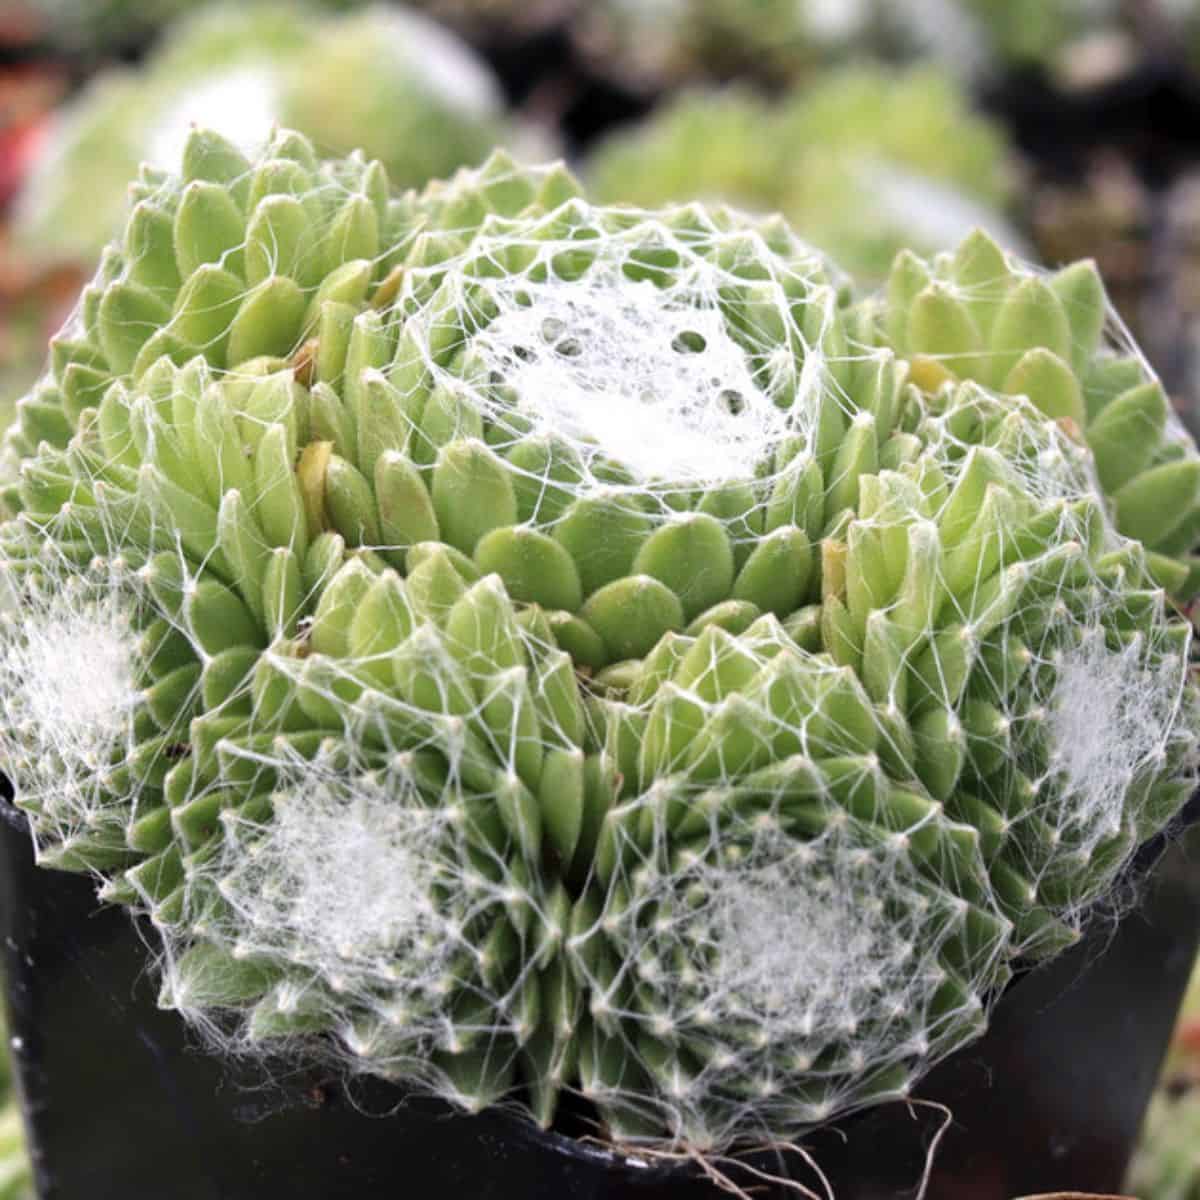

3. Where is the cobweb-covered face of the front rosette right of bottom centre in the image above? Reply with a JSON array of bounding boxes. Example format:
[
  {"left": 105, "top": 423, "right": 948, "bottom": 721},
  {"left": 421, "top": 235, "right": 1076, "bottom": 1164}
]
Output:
[{"left": 575, "top": 798, "right": 1008, "bottom": 1151}]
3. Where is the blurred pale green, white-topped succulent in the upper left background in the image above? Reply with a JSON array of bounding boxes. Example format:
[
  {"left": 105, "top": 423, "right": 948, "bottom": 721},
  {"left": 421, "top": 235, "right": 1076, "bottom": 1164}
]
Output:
[{"left": 13, "top": 2, "right": 515, "bottom": 264}]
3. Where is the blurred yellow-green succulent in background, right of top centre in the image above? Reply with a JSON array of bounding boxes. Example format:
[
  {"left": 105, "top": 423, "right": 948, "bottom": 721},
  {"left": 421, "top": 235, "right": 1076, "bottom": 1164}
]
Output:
[{"left": 586, "top": 66, "right": 1020, "bottom": 280}]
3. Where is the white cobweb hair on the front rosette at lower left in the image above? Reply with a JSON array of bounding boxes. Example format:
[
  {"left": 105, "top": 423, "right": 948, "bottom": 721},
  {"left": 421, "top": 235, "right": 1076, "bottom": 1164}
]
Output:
[{"left": 163, "top": 739, "right": 499, "bottom": 1082}]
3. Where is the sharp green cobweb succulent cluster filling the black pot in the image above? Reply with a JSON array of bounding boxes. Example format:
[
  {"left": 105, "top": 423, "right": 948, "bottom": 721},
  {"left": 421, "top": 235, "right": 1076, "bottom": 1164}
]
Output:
[{"left": 0, "top": 132, "right": 1196, "bottom": 1148}]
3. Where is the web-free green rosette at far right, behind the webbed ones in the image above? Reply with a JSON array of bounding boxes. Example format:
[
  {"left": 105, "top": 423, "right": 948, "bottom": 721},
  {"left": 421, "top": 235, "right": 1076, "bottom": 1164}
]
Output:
[{"left": 882, "top": 226, "right": 1200, "bottom": 595}]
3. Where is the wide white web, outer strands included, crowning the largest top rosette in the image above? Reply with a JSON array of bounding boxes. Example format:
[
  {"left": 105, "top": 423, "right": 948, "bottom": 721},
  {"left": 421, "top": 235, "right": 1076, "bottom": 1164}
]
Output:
[{"left": 400, "top": 199, "right": 848, "bottom": 516}]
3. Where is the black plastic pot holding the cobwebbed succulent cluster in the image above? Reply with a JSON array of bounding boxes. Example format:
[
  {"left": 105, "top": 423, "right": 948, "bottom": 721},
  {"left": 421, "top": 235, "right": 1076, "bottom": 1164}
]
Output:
[{"left": 0, "top": 787, "right": 1200, "bottom": 1200}]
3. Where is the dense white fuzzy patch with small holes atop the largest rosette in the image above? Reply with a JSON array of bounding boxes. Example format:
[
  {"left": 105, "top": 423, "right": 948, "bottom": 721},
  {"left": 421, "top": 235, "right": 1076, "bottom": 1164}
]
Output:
[{"left": 475, "top": 269, "right": 787, "bottom": 482}]
